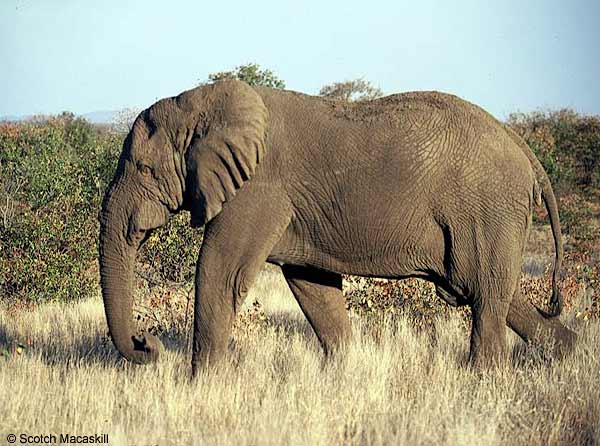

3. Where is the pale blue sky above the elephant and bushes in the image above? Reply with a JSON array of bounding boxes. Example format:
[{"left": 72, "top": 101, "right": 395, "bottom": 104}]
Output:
[{"left": 0, "top": 0, "right": 600, "bottom": 118}]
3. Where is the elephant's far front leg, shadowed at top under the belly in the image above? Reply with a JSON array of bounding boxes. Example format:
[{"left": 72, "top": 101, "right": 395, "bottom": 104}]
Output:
[{"left": 282, "top": 265, "right": 351, "bottom": 355}]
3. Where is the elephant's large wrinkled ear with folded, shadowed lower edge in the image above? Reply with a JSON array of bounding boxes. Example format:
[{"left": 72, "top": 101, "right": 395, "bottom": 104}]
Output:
[{"left": 186, "top": 80, "right": 267, "bottom": 227}]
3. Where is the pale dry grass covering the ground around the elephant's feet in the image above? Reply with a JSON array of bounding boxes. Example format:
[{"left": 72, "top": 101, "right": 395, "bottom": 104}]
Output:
[{"left": 0, "top": 273, "right": 600, "bottom": 445}]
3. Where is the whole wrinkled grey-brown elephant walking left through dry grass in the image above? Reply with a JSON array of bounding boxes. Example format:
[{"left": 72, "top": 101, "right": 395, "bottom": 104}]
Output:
[{"left": 100, "top": 81, "right": 575, "bottom": 373}]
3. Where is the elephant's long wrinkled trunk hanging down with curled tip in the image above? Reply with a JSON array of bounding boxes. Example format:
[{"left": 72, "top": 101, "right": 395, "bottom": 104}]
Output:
[{"left": 100, "top": 186, "right": 163, "bottom": 364}]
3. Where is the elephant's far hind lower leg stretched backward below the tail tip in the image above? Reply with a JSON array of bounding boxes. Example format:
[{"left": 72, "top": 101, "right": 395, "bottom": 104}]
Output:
[{"left": 507, "top": 291, "right": 577, "bottom": 358}]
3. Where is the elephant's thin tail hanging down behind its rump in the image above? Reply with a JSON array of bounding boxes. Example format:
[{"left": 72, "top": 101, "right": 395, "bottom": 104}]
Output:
[{"left": 504, "top": 125, "right": 564, "bottom": 318}]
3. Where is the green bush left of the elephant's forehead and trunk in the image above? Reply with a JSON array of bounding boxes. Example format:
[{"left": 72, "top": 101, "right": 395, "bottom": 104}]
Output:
[{"left": 0, "top": 114, "right": 122, "bottom": 301}]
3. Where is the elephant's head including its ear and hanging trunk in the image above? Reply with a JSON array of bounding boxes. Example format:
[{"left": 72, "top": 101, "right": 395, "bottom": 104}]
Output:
[{"left": 100, "top": 81, "right": 267, "bottom": 363}]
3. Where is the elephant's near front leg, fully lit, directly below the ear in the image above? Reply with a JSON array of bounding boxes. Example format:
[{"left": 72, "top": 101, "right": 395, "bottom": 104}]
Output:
[{"left": 192, "top": 199, "right": 289, "bottom": 376}]
